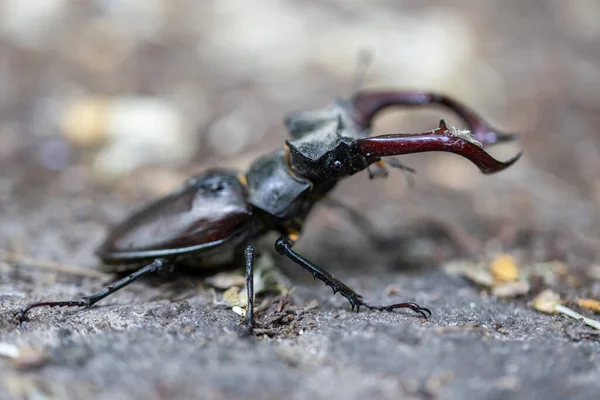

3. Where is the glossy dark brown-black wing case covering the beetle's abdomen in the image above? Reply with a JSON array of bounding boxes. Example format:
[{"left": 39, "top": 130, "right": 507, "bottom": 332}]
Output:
[{"left": 96, "top": 170, "right": 253, "bottom": 263}]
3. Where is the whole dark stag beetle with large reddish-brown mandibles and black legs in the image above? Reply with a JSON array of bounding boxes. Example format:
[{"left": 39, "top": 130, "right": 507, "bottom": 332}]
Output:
[{"left": 19, "top": 91, "right": 521, "bottom": 326}]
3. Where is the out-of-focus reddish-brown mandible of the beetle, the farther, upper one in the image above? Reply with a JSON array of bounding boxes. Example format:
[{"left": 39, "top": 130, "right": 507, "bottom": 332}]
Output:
[{"left": 351, "top": 91, "right": 516, "bottom": 146}]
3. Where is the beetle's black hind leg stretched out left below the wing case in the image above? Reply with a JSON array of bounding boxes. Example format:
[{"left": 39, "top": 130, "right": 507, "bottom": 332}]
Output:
[{"left": 18, "top": 258, "right": 170, "bottom": 323}]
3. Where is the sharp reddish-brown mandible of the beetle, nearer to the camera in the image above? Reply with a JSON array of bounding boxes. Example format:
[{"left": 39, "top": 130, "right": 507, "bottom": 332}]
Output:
[{"left": 356, "top": 120, "right": 522, "bottom": 174}]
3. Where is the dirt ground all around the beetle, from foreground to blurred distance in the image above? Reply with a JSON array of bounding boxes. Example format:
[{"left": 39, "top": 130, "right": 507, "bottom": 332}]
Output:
[{"left": 0, "top": 0, "right": 600, "bottom": 400}]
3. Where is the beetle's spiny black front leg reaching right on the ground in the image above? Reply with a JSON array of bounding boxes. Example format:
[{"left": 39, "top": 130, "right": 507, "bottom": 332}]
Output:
[{"left": 275, "top": 236, "right": 431, "bottom": 319}]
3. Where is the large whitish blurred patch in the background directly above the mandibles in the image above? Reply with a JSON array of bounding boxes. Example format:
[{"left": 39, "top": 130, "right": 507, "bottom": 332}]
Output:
[{"left": 310, "top": 8, "right": 477, "bottom": 90}]
